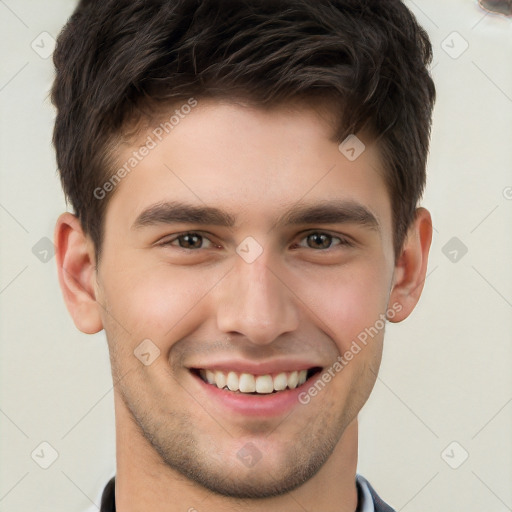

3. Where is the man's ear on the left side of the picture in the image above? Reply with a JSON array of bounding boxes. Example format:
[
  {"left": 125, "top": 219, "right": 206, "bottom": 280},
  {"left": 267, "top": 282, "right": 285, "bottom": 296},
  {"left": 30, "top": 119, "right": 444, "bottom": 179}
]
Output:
[{"left": 54, "top": 213, "right": 103, "bottom": 334}]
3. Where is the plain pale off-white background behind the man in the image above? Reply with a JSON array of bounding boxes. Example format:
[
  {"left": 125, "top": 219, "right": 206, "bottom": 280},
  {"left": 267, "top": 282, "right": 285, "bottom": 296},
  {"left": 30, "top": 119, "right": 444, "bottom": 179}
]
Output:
[{"left": 0, "top": 0, "right": 512, "bottom": 512}]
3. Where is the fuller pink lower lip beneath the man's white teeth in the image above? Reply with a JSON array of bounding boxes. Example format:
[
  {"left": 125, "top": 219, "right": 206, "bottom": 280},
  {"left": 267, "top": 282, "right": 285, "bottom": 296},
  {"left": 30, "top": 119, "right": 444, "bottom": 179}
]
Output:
[{"left": 191, "top": 372, "right": 311, "bottom": 417}]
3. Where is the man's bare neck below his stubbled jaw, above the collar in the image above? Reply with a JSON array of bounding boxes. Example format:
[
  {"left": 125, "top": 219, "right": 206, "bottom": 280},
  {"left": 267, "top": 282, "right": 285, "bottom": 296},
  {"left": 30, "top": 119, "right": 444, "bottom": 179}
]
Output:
[{"left": 115, "top": 397, "right": 357, "bottom": 512}]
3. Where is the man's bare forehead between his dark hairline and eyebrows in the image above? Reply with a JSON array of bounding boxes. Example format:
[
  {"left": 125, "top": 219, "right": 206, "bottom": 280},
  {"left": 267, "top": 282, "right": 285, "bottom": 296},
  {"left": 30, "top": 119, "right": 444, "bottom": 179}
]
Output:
[{"left": 107, "top": 100, "right": 390, "bottom": 234}]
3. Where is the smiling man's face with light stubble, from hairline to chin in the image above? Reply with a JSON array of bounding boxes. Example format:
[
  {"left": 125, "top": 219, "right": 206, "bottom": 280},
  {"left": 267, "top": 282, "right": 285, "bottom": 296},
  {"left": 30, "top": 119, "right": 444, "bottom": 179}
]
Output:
[{"left": 95, "top": 101, "right": 394, "bottom": 497}]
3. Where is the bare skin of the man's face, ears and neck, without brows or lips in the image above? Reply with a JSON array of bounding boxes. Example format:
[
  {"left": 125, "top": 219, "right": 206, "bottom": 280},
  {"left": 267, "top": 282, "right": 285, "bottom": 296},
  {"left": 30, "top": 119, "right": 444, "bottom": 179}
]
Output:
[{"left": 55, "top": 101, "right": 432, "bottom": 512}]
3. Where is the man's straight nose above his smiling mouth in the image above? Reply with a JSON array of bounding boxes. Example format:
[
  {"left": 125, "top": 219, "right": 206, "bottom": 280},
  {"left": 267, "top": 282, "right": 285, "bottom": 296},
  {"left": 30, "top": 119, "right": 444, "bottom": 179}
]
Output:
[{"left": 215, "top": 252, "right": 299, "bottom": 345}]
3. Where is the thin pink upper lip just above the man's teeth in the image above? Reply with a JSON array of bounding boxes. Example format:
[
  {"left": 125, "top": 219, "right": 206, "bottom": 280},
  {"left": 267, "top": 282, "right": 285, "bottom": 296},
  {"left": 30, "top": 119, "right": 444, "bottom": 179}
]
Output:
[{"left": 189, "top": 359, "right": 322, "bottom": 375}]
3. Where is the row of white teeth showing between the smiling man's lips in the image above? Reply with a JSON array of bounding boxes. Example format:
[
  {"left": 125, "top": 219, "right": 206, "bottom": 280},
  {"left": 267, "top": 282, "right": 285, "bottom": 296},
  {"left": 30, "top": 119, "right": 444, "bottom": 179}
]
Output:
[{"left": 190, "top": 366, "right": 322, "bottom": 395}]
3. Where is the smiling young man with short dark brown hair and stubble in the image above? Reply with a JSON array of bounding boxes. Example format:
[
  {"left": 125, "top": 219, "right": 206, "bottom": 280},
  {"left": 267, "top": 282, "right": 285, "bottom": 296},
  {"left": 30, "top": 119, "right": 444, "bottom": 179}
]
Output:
[{"left": 52, "top": 0, "right": 435, "bottom": 512}]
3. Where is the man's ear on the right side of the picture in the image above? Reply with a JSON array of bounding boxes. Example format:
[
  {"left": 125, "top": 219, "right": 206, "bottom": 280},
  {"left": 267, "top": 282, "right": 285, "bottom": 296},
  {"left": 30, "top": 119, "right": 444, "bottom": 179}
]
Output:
[{"left": 389, "top": 208, "right": 432, "bottom": 322}]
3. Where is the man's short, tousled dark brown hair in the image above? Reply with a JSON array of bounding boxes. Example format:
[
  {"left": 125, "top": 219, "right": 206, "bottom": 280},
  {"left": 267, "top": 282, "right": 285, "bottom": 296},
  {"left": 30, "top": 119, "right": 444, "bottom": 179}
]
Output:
[{"left": 52, "top": 0, "right": 435, "bottom": 261}]
